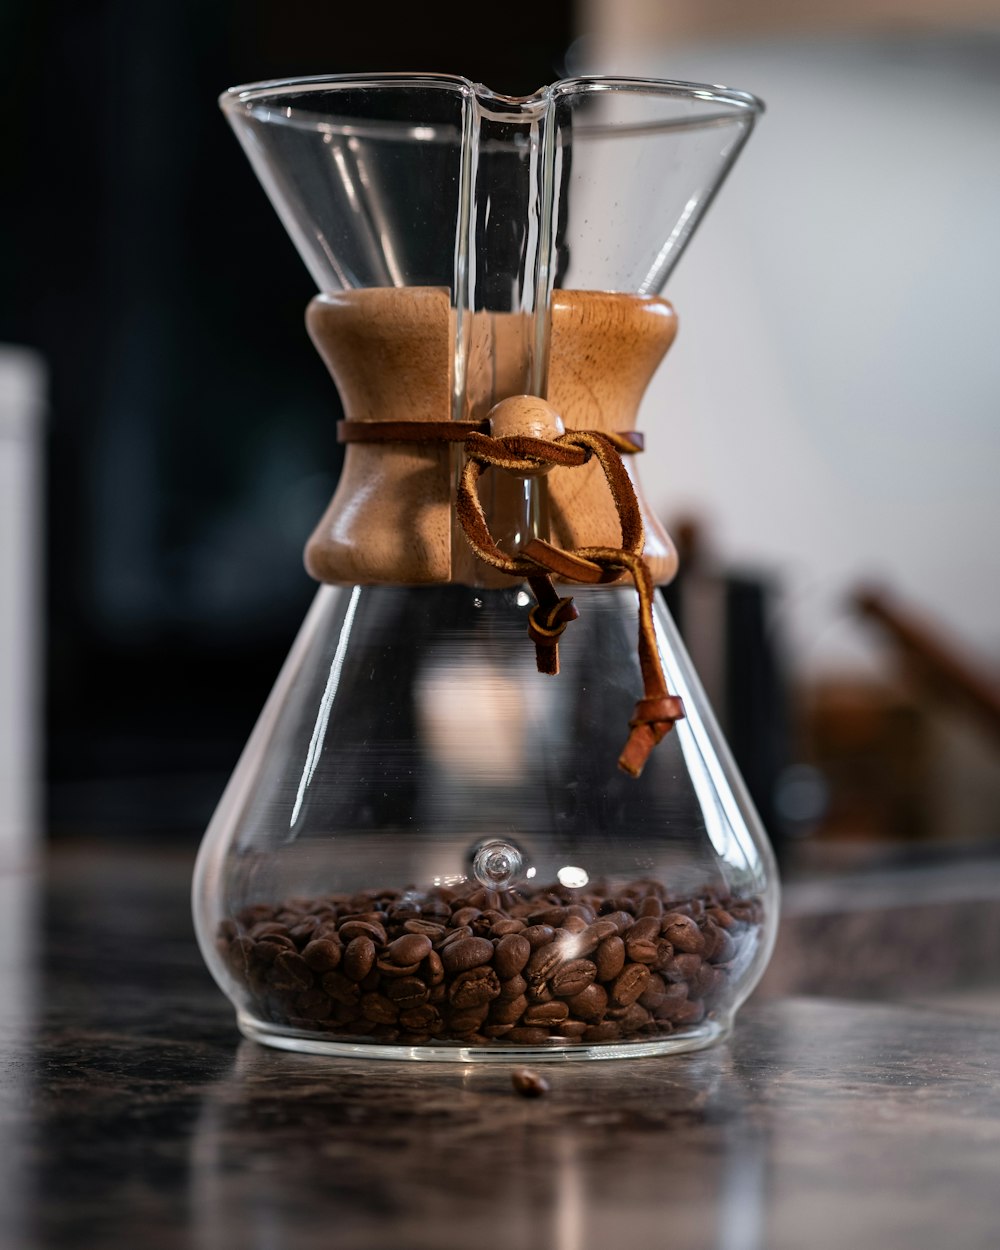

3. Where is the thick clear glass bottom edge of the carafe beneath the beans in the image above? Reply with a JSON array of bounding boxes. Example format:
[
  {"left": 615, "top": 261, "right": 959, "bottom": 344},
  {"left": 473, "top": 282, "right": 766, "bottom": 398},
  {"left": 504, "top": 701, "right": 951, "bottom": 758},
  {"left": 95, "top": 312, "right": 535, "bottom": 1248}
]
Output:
[{"left": 236, "top": 1011, "right": 733, "bottom": 1064}]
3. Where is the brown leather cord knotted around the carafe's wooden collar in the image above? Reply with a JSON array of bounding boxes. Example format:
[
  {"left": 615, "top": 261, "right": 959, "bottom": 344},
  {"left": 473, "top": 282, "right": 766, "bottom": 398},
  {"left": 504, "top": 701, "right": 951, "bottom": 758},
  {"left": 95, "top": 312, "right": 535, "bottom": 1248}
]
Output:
[{"left": 338, "top": 421, "right": 684, "bottom": 778}]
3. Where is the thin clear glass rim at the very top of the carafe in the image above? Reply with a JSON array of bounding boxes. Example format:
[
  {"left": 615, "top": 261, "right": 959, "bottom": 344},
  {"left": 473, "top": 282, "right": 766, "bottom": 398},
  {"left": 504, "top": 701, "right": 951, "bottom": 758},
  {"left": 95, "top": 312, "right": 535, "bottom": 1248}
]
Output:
[{"left": 219, "top": 71, "right": 765, "bottom": 138}]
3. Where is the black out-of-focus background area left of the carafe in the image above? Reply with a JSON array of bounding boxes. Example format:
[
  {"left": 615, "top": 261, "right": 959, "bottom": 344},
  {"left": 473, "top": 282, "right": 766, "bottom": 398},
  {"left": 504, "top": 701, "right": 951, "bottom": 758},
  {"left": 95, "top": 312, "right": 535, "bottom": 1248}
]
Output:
[{"left": 0, "top": 0, "right": 574, "bottom": 838}]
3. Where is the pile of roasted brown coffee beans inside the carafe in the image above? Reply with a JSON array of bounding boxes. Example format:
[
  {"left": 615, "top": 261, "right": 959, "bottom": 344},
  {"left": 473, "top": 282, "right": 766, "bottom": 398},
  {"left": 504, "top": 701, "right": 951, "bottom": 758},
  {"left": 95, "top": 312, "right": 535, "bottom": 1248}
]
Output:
[{"left": 218, "top": 881, "right": 763, "bottom": 1046}]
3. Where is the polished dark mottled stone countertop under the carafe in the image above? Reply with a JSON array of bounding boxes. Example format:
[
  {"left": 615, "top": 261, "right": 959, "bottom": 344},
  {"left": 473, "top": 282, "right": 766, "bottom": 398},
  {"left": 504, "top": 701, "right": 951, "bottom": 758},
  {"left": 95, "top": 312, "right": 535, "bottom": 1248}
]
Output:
[{"left": 0, "top": 848, "right": 1000, "bottom": 1250}]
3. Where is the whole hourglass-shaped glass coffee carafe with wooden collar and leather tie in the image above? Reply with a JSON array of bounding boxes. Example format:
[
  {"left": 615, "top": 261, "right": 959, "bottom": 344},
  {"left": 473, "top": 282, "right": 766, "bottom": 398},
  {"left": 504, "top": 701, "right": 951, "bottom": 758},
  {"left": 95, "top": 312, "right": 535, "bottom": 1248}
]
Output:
[{"left": 194, "top": 74, "right": 778, "bottom": 1060}]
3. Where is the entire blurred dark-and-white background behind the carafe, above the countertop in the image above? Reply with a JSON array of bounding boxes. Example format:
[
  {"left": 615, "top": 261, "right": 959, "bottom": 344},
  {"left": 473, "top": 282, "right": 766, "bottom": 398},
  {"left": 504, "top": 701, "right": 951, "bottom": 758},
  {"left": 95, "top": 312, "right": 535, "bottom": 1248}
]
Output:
[{"left": 0, "top": 0, "right": 1000, "bottom": 878}]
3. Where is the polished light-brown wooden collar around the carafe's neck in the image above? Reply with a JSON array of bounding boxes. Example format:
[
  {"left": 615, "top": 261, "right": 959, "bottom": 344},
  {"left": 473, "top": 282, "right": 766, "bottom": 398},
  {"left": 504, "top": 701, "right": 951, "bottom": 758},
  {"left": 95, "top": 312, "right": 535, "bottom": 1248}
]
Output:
[{"left": 305, "top": 288, "right": 676, "bottom": 585}]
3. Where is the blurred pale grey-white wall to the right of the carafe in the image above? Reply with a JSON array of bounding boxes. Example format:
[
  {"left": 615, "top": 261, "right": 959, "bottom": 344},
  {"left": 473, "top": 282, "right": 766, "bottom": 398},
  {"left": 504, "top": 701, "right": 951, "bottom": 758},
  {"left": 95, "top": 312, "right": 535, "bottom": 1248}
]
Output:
[{"left": 571, "top": 26, "right": 1000, "bottom": 673}]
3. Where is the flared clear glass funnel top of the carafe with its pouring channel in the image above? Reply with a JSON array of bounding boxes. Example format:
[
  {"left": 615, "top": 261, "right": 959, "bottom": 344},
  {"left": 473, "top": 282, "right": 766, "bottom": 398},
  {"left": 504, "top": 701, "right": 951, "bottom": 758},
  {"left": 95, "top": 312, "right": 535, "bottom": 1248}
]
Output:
[{"left": 220, "top": 74, "right": 763, "bottom": 420}]
